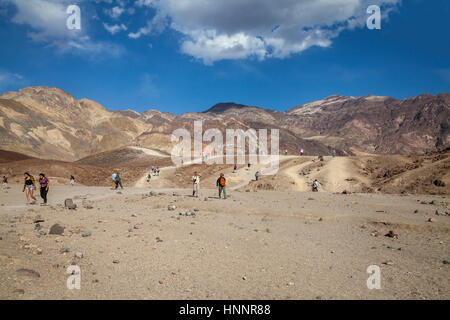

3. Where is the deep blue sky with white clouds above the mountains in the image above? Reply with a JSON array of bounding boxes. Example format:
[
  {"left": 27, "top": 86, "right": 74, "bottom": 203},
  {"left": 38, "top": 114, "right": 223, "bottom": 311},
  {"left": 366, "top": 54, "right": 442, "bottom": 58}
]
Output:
[{"left": 0, "top": 0, "right": 450, "bottom": 113}]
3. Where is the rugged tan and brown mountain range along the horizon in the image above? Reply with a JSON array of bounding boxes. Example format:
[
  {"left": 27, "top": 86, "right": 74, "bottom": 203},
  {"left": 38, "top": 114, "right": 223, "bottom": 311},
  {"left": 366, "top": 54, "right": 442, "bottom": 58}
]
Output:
[{"left": 0, "top": 87, "right": 450, "bottom": 161}]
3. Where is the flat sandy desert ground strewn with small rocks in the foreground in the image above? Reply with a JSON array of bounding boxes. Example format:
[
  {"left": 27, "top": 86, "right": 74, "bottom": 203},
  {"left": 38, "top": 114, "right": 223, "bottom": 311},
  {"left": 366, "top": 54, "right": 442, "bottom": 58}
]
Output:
[{"left": 0, "top": 185, "right": 450, "bottom": 299}]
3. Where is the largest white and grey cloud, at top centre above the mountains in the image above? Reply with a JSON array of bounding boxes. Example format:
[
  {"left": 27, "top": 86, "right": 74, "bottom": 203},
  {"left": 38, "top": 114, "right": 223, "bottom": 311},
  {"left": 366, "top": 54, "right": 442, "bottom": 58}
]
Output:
[{"left": 135, "top": 0, "right": 401, "bottom": 64}]
